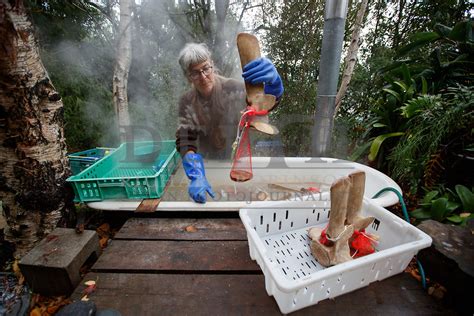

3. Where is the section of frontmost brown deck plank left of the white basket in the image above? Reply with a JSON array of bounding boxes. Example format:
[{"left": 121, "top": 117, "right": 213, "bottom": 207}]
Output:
[{"left": 73, "top": 273, "right": 279, "bottom": 316}]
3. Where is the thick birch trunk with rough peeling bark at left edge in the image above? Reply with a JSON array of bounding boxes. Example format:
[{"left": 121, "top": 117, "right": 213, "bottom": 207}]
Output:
[{"left": 0, "top": 0, "right": 70, "bottom": 257}]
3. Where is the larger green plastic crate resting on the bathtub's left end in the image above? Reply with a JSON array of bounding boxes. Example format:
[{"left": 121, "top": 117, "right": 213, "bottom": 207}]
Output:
[{"left": 67, "top": 140, "right": 180, "bottom": 202}]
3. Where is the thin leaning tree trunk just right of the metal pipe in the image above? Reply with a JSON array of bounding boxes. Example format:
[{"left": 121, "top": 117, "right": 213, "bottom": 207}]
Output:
[{"left": 334, "top": 0, "right": 369, "bottom": 117}]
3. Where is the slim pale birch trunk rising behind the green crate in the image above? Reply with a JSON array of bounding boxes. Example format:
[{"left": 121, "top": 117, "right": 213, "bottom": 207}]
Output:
[{"left": 113, "top": 0, "right": 132, "bottom": 141}]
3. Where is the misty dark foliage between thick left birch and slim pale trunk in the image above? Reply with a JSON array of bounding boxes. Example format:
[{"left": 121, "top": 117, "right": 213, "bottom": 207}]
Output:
[{"left": 25, "top": 1, "right": 117, "bottom": 152}]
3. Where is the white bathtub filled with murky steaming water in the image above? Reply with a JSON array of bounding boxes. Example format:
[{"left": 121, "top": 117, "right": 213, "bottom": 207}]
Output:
[{"left": 88, "top": 157, "right": 402, "bottom": 211}]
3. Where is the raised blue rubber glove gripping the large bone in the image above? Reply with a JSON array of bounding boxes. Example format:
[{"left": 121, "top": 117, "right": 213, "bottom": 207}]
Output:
[{"left": 242, "top": 58, "right": 283, "bottom": 98}]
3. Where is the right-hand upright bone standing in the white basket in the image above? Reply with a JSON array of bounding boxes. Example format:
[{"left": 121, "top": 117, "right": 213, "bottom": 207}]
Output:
[{"left": 345, "top": 171, "right": 375, "bottom": 230}]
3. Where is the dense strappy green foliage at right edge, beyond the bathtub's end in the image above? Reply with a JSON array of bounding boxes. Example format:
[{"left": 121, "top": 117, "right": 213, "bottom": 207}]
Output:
[{"left": 359, "top": 21, "right": 474, "bottom": 193}]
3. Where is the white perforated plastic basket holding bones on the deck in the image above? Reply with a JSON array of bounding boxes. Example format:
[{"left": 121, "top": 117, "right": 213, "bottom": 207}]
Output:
[{"left": 240, "top": 199, "right": 431, "bottom": 314}]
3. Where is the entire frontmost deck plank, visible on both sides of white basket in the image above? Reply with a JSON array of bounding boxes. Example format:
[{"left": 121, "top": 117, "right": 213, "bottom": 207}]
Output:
[{"left": 72, "top": 273, "right": 455, "bottom": 316}]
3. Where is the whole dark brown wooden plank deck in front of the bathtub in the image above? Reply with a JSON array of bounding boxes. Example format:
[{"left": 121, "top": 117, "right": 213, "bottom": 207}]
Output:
[{"left": 72, "top": 212, "right": 453, "bottom": 316}]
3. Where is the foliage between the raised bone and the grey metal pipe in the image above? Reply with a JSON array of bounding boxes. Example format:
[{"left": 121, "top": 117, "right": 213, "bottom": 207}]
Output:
[{"left": 263, "top": 1, "right": 324, "bottom": 156}]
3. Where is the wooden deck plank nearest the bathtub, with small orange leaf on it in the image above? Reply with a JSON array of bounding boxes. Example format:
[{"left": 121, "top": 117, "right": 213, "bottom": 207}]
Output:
[{"left": 114, "top": 218, "right": 247, "bottom": 240}]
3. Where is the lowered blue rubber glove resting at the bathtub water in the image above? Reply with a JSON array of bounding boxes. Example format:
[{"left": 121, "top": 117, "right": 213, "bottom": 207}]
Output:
[{"left": 183, "top": 153, "right": 215, "bottom": 203}]
